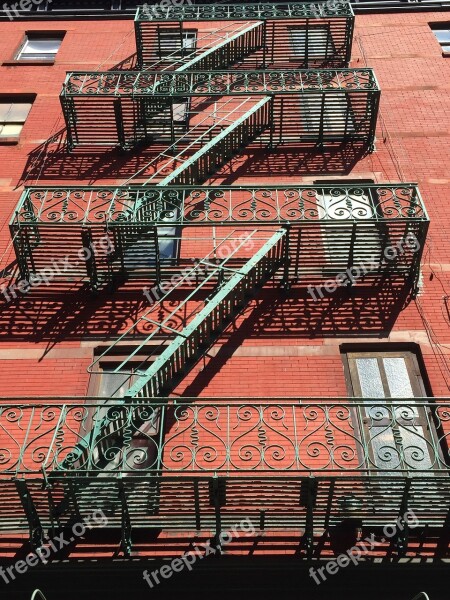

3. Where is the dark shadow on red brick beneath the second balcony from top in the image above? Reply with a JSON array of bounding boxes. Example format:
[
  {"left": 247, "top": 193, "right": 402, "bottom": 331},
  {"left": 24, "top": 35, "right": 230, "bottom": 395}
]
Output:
[{"left": 18, "top": 129, "right": 368, "bottom": 185}]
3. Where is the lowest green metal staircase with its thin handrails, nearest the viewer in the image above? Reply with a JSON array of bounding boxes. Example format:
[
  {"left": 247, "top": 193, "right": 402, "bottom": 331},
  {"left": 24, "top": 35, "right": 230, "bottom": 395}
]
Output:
[{"left": 53, "top": 227, "right": 289, "bottom": 482}]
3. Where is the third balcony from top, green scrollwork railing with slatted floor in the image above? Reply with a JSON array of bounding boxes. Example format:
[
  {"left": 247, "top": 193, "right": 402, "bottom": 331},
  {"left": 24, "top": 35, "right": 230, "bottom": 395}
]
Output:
[{"left": 10, "top": 182, "right": 429, "bottom": 286}]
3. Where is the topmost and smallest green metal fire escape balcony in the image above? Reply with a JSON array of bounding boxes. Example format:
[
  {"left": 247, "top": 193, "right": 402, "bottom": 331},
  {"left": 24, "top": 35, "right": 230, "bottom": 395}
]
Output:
[{"left": 135, "top": 2, "right": 355, "bottom": 69}]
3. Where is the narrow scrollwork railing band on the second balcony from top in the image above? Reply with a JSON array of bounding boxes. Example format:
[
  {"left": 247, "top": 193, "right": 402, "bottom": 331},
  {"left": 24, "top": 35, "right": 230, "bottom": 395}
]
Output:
[{"left": 61, "top": 69, "right": 379, "bottom": 98}]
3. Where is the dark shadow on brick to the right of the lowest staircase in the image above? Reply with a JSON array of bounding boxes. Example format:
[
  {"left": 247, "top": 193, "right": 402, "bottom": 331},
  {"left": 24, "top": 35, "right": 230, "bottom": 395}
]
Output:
[{"left": 177, "top": 277, "right": 413, "bottom": 397}]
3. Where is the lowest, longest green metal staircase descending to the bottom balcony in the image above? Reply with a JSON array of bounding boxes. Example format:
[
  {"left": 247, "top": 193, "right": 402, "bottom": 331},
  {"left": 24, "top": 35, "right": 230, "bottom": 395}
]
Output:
[{"left": 53, "top": 227, "right": 289, "bottom": 475}]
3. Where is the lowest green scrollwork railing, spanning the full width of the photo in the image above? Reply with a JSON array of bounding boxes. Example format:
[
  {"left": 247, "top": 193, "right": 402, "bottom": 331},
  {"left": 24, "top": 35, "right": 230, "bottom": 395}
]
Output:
[{"left": 0, "top": 399, "right": 450, "bottom": 477}]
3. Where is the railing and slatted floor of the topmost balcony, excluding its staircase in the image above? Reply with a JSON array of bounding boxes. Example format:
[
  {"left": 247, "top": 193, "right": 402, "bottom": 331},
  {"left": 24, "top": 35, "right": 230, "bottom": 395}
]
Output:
[{"left": 135, "top": 2, "right": 354, "bottom": 69}]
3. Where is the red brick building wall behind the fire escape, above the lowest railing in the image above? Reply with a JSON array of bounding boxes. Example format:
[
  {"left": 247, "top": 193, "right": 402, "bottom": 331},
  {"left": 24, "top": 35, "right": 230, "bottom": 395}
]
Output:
[{"left": 0, "top": 12, "right": 450, "bottom": 396}]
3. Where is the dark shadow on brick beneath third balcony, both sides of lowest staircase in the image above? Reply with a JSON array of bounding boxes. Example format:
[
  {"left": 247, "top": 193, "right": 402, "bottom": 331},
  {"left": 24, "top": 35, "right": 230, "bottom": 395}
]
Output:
[{"left": 0, "top": 276, "right": 413, "bottom": 346}]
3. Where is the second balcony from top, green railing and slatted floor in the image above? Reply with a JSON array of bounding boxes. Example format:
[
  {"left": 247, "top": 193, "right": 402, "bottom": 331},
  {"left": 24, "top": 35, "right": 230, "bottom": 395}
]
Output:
[{"left": 61, "top": 68, "right": 380, "bottom": 151}]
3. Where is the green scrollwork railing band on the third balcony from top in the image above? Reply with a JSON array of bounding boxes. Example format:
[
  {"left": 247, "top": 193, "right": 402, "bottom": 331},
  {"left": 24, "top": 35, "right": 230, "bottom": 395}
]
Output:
[{"left": 11, "top": 182, "right": 428, "bottom": 227}]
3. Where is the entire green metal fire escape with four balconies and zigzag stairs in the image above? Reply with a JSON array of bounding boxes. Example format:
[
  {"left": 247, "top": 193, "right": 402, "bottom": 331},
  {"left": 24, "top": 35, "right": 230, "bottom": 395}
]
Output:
[{"left": 0, "top": 3, "right": 450, "bottom": 556}]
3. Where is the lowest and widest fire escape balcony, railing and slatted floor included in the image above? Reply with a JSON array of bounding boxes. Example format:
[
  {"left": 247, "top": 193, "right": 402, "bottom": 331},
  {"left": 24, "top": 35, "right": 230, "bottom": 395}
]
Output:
[{"left": 0, "top": 398, "right": 450, "bottom": 551}]
